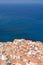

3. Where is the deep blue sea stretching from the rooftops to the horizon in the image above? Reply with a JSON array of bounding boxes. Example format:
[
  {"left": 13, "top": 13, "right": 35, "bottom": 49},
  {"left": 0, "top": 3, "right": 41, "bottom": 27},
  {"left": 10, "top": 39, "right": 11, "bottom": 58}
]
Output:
[{"left": 0, "top": 4, "right": 43, "bottom": 42}]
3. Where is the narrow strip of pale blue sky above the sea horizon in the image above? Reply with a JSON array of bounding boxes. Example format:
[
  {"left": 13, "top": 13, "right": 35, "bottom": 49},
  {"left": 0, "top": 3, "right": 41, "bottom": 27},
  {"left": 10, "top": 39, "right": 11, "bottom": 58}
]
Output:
[{"left": 0, "top": 0, "right": 43, "bottom": 3}]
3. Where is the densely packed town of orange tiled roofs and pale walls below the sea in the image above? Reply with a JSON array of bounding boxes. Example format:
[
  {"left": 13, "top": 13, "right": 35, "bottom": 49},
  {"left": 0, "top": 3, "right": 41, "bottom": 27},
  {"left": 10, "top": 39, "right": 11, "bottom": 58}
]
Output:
[{"left": 0, "top": 39, "right": 43, "bottom": 65}]
